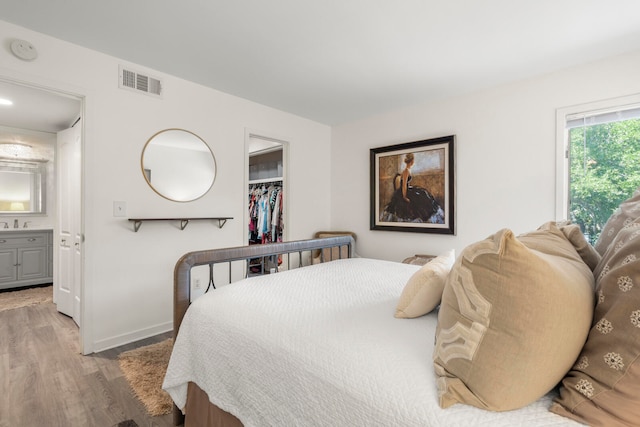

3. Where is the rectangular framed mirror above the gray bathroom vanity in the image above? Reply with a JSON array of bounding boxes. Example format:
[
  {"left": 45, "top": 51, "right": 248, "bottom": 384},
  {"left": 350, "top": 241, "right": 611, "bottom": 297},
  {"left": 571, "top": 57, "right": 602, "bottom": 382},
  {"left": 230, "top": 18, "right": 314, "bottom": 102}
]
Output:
[{"left": 0, "top": 160, "right": 46, "bottom": 216}]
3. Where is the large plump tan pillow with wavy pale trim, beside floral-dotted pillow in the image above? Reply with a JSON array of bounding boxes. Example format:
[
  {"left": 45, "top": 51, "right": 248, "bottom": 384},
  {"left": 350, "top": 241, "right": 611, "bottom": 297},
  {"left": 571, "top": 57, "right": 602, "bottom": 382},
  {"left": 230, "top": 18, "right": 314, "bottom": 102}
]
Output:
[{"left": 434, "top": 223, "right": 594, "bottom": 411}]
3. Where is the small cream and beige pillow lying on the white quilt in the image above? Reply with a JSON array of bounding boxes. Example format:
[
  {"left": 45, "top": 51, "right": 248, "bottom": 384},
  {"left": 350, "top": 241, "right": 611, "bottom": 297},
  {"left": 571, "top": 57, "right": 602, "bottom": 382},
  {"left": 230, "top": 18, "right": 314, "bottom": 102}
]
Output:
[{"left": 395, "top": 250, "right": 456, "bottom": 319}]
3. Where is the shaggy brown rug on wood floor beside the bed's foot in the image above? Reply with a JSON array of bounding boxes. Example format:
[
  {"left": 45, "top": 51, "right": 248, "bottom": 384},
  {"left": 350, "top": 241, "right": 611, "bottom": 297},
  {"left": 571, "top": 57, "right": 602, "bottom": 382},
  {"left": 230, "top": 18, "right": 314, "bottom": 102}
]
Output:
[{"left": 118, "top": 338, "right": 173, "bottom": 416}]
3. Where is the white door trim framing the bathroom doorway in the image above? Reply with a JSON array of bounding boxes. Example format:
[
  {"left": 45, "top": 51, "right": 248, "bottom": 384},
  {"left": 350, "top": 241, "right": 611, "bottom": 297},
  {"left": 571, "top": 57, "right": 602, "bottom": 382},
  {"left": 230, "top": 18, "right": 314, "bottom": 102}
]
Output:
[{"left": 0, "top": 72, "right": 88, "bottom": 355}]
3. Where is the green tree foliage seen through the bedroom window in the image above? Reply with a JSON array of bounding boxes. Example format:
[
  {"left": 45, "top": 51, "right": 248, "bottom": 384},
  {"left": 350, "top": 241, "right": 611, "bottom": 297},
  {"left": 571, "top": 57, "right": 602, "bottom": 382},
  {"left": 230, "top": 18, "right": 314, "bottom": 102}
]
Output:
[{"left": 569, "top": 119, "right": 640, "bottom": 243}]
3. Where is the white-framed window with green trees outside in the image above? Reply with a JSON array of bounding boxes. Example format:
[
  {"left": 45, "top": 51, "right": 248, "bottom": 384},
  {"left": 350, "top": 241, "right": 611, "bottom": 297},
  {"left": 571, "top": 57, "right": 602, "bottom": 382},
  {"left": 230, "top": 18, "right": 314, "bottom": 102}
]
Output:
[{"left": 556, "top": 96, "right": 640, "bottom": 243}]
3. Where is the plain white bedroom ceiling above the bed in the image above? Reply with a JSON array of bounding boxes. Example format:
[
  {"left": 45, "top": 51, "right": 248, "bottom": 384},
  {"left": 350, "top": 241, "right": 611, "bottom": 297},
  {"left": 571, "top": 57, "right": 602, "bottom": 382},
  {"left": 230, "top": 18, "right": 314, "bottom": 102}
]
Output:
[{"left": 0, "top": 0, "right": 640, "bottom": 130}]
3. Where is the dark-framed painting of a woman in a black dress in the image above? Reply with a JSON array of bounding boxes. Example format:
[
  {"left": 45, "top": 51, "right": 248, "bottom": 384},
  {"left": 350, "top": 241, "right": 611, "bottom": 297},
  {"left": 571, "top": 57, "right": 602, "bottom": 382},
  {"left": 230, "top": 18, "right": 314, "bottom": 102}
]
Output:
[{"left": 370, "top": 135, "right": 455, "bottom": 234}]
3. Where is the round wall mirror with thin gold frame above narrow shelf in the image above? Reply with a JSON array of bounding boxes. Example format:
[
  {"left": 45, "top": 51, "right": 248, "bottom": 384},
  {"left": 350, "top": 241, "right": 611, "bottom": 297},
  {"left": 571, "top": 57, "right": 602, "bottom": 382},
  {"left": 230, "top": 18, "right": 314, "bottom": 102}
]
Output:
[{"left": 141, "top": 129, "right": 216, "bottom": 202}]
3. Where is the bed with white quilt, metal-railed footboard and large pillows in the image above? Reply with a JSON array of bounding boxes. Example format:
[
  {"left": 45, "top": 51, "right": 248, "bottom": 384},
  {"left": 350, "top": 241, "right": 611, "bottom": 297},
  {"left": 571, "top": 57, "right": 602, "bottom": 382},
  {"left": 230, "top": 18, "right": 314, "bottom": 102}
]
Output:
[{"left": 163, "top": 205, "right": 640, "bottom": 427}]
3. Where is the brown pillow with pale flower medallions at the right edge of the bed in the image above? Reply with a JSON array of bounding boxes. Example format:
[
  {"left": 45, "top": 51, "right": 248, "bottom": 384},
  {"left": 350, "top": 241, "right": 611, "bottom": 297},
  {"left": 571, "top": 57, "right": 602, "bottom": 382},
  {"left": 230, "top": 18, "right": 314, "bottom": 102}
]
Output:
[{"left": 551, "top": 218, "right": 640, "bottom": 426}]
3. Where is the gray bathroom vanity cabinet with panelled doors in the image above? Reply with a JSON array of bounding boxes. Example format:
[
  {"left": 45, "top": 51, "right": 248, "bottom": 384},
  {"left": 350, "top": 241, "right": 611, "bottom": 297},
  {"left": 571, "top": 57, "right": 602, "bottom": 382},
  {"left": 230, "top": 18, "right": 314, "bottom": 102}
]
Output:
[{"left": 0, "top": 230, "right": 53, "bottom": 289}]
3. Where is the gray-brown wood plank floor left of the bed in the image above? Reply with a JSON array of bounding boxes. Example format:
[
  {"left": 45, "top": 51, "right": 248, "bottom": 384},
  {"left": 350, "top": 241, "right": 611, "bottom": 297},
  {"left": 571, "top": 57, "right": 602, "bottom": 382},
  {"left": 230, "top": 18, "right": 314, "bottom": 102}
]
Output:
[{"left": 0, "top": 303, "right": 173, "bottom": 427}]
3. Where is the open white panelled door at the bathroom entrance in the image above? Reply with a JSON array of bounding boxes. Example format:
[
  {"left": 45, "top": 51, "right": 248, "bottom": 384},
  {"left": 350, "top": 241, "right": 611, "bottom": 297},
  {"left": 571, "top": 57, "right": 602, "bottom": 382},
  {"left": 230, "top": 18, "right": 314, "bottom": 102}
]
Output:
[{"left": 54, "top": 123, "right": 82, "bottom": 326}]
